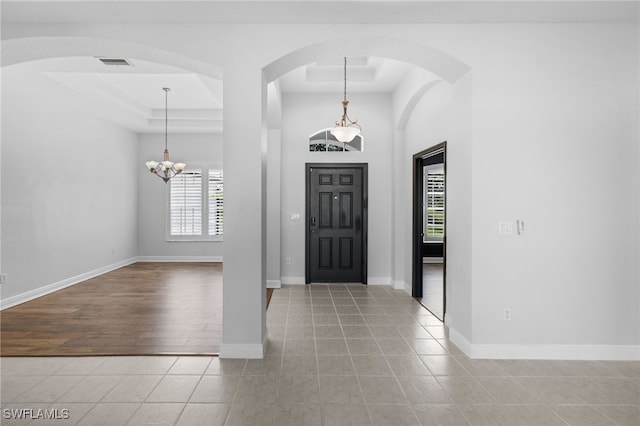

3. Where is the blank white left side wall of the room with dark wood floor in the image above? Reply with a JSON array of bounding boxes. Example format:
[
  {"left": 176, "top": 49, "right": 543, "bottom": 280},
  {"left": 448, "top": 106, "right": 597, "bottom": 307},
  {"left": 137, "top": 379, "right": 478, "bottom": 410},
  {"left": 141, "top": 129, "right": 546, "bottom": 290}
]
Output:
[{"left": 1, "top": 62, "right": 138, "bottom": 306}]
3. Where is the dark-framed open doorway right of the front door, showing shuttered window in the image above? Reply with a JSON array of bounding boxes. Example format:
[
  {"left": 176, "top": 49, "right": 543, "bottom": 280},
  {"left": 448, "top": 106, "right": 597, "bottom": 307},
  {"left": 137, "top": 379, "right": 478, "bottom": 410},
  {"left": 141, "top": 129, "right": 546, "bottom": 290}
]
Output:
[{"left": 411, "top": 142, "right": 447, "bottom": 321}]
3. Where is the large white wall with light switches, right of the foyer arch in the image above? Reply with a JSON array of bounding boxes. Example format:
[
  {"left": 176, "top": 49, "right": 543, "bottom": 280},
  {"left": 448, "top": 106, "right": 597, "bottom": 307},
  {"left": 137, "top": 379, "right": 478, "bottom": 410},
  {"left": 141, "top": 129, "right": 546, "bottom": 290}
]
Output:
[{"left": 464, "top": 25, "right": 640, "bottom": 355}]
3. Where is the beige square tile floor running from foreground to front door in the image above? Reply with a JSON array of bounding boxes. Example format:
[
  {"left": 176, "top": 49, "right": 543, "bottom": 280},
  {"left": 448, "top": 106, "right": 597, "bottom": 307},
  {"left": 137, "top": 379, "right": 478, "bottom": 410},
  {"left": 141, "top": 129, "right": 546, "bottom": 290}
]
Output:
[{"left": 0, "top": 285, "right": 640, "bottom": 426}]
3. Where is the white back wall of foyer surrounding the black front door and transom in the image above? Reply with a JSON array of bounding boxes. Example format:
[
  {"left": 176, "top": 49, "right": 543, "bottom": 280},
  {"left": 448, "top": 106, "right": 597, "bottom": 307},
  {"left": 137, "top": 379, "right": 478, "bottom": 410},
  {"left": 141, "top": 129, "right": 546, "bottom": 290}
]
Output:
[{"left": 281, "top": 93, "right": 393, "bottom": 285}]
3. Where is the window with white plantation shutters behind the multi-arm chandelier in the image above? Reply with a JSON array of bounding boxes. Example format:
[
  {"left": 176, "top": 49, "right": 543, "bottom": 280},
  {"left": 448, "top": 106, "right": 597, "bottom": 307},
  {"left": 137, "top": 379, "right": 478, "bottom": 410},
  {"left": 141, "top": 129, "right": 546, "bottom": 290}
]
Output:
[{"left": 167, "top": 167, "right": 224, "bottom": 241}]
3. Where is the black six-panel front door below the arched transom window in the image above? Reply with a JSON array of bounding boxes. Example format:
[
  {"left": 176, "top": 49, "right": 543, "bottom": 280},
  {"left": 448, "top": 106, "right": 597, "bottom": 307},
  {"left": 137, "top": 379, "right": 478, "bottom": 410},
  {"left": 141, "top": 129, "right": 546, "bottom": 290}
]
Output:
[{"left": 306, "top": 164, "right": 367, "bottom": 283}]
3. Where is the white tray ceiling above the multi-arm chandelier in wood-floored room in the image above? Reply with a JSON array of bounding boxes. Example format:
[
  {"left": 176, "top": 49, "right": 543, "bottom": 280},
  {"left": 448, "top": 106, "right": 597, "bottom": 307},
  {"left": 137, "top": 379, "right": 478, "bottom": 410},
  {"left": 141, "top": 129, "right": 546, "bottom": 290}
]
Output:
[{"left": 32, "top": 57, "right": 223, "bottom": 133}]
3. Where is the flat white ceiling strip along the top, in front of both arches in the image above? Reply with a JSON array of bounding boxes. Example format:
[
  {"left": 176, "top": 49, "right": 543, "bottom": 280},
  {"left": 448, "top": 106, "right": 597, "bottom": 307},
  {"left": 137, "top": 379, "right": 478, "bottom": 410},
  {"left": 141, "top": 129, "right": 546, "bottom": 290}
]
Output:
[{"left": 2, "top": 0, "right": 639, "bottom": 24}]
